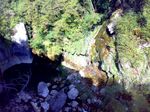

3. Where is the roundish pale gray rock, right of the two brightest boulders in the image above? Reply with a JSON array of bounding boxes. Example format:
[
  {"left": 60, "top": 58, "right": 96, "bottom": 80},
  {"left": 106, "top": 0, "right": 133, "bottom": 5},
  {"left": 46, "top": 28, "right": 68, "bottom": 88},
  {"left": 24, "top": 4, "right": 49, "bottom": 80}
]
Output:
[{"left": 67, "top": 88, "right": 79, "bottom": 100}]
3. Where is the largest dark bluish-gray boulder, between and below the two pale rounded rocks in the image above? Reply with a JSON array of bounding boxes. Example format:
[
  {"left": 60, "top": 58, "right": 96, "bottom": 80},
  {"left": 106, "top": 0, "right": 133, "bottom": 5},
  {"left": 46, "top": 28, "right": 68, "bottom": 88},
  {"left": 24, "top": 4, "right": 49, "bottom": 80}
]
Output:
[{"left": 49, "top": 91, "right": 67, "bottom": 112}]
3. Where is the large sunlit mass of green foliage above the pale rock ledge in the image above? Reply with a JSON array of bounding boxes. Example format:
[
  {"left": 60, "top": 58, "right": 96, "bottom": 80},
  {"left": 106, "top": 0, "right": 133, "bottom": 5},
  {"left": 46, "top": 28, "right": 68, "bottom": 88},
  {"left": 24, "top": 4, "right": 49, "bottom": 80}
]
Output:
[{"left": 7, "top": 0, "right": 99, "bottom": 57}]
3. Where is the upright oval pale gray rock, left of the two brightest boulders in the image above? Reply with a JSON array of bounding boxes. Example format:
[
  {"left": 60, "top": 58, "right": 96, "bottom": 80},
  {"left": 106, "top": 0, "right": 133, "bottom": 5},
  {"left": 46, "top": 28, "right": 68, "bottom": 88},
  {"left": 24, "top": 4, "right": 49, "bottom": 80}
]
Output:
[{"left": 38, "top": 82, "right": 49, "bottom": 98}]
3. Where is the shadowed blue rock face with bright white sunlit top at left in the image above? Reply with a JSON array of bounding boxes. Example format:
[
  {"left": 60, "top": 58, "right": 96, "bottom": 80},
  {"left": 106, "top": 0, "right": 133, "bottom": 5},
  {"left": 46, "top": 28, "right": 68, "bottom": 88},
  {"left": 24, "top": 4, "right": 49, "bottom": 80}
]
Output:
[{"left": 0, "top": 23, "right": 32, "bottom": 74}]
